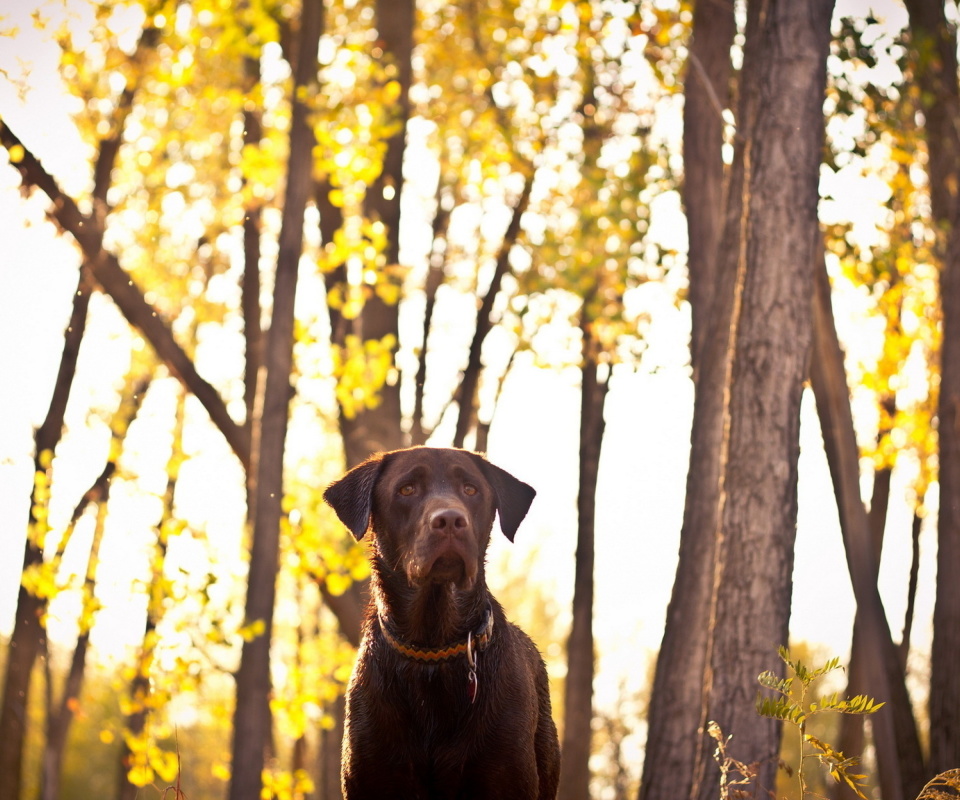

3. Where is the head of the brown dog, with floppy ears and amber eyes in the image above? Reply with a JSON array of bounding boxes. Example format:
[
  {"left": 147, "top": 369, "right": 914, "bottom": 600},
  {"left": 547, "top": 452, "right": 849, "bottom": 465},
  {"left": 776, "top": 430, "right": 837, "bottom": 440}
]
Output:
[{"left": 323, "top": 447, "right": 536, "bottom": 589}]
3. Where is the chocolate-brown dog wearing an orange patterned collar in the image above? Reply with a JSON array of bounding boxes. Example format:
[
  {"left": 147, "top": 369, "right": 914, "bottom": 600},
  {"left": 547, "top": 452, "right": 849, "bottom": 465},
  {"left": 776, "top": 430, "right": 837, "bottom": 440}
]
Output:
[{"left": 324, "top": 447, "right": 560, "bottom": 800}]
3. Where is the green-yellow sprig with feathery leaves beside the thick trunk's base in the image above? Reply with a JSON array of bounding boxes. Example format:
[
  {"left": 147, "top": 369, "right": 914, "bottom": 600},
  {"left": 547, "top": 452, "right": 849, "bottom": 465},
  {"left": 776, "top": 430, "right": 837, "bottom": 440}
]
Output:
[{"left": 757, "top": 647, "right": 884, "bottom": 800}]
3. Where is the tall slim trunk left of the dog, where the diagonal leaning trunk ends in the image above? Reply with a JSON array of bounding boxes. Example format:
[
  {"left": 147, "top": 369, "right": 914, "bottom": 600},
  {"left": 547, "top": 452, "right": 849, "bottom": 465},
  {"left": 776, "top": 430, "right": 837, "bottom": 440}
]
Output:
[{"left": 229, "top": 0, "right": 323, "bottom": 800}]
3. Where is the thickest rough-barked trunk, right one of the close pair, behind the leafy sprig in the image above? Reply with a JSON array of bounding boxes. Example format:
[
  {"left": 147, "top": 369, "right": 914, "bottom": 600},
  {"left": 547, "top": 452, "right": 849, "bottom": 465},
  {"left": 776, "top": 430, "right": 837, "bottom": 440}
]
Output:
[{"left": 698, "top": 0, "right": 833, "bottom": 800}]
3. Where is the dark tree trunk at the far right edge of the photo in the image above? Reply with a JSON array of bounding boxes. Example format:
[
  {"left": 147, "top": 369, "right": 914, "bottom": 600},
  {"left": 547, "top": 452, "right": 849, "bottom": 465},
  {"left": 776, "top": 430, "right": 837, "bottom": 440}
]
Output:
[{"left": 905, "top": 0, "right": 960, "bottom": 772}]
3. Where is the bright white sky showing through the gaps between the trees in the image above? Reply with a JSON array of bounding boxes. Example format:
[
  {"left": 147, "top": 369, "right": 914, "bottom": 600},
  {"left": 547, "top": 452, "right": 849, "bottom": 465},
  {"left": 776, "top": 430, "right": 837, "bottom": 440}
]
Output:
[{"left": 0, "top": 0, "right": 935, "bottom": 732}]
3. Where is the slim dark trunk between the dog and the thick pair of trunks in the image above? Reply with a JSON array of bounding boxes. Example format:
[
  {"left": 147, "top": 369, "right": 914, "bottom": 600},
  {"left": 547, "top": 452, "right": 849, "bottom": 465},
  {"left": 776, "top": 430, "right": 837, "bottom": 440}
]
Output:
[{"left": 557, "top": 314, "right": 610, "bottom": 800}]
